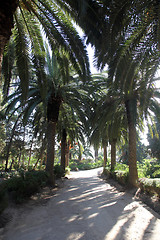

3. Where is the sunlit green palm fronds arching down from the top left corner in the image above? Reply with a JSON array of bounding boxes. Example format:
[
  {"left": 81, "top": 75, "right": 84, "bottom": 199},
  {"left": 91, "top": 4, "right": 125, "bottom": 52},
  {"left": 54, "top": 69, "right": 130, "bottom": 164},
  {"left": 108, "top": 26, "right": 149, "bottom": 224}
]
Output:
[{"left": 0, "top": 0, "right": 89, "bottom": 98}]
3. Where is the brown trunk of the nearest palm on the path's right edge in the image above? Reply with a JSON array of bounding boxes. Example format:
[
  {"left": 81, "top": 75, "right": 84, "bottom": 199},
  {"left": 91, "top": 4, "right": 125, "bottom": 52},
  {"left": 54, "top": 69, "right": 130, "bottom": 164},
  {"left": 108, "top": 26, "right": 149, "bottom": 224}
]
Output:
[{"left": 126, "top": 100, "right": 138, "bottom": 187}]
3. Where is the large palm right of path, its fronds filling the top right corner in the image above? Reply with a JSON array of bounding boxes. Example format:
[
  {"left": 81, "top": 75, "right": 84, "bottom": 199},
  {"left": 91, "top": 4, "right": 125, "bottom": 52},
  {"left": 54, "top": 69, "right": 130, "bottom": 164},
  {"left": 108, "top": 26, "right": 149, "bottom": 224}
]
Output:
[{"left": 61, "top": 1, "right": 160, "bottom": 186}]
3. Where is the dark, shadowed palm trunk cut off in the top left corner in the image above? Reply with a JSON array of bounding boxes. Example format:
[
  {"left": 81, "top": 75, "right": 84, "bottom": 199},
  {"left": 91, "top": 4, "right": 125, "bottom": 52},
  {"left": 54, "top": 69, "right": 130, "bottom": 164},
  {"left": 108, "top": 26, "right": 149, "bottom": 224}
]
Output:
[{"left": 0, "top": 0, "right": 18, "bottom": 78}]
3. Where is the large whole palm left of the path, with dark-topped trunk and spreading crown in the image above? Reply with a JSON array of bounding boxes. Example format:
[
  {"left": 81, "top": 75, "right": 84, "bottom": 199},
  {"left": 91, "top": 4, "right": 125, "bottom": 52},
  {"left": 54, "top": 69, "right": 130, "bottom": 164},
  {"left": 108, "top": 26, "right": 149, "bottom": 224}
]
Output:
[{"left": 2, "top": 44, "right": 91, "bottom": 185}]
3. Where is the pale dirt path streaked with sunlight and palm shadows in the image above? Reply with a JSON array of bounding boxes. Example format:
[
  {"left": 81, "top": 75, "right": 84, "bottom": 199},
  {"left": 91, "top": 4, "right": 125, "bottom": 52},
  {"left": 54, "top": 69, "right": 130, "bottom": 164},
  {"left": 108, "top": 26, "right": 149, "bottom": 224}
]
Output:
[{"left": 0, "top": 170, "right": 160, "bottom": 240}]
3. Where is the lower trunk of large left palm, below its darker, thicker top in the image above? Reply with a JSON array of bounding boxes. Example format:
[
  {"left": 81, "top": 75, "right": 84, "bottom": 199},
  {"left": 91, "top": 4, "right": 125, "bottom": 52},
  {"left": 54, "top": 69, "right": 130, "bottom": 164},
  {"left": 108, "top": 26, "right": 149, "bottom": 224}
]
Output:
[{"left": 46, "top": 121, "right": 56, "bottom": 186}]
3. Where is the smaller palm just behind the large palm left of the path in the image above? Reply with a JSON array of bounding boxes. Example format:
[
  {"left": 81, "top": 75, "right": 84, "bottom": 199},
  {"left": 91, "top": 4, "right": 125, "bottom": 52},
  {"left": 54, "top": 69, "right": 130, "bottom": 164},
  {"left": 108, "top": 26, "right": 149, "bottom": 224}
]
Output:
[{"left": 57, "top": 102, "right": 88, "bottom": 169}]
